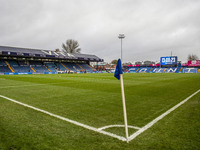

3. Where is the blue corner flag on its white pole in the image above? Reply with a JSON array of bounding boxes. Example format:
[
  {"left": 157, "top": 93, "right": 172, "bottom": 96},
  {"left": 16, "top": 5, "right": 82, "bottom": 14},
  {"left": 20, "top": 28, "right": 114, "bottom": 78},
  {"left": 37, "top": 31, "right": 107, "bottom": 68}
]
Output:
[{"left": 114, "top": 59, "right": 128, "bottom": 143}]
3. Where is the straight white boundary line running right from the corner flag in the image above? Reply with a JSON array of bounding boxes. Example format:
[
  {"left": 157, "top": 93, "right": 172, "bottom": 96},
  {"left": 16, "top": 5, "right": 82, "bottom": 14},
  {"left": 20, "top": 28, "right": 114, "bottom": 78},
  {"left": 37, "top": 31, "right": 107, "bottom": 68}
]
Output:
[{"left": 128, "top": 89, "right": 200, "bottom": 141}]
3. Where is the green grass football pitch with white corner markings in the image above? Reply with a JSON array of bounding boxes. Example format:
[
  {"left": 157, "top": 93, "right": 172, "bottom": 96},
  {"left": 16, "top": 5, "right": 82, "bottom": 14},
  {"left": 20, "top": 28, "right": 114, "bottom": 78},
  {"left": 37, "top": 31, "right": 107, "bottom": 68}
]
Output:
[{"left": 0, "top": 73, "right": 200, "bottom": 150}]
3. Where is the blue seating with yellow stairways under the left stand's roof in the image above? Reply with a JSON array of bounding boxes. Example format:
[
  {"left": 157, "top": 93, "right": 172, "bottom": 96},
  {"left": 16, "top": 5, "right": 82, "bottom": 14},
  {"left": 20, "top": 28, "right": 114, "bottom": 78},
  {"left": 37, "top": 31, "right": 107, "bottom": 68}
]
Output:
[{"left": 0, "top": 59, "right": 93, "bottom": 73}]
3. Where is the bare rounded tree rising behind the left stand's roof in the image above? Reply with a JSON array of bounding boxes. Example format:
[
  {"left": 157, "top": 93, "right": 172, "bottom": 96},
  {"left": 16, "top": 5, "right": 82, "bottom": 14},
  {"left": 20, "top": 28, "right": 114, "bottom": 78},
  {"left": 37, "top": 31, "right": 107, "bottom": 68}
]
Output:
[{"left": 62, "top": 39, "right": 81, "bottom": 53}]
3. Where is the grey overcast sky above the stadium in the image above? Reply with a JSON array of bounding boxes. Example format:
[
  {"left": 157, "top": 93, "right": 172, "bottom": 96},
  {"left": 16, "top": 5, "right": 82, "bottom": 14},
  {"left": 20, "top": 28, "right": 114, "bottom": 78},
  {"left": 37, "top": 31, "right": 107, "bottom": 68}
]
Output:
[{"left": 0, "top": 0, "right": 200, "bottom": 62}]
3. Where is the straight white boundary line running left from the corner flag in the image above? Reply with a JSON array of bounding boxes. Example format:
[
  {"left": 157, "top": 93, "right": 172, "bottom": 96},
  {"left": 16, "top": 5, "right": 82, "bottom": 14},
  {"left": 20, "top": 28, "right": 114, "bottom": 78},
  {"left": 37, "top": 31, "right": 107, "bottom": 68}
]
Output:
[{"left": 0, "top": 95, "right": 126, "bottom": 141}]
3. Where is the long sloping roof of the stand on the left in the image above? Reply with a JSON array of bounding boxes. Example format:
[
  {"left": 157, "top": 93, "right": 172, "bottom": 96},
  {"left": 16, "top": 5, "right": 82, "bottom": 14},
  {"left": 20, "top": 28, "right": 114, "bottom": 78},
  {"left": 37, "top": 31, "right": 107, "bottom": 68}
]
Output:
[{"left": 0, "top": 46, "right": 103, "bottom": 62}]
